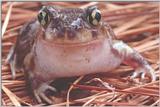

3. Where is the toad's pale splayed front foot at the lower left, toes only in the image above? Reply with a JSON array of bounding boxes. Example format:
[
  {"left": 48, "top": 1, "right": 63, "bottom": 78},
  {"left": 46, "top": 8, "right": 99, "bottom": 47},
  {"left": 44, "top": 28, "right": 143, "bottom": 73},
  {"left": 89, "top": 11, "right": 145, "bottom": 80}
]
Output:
[{"left": 33, "top": 83, "right": 56, "bottom": 104}]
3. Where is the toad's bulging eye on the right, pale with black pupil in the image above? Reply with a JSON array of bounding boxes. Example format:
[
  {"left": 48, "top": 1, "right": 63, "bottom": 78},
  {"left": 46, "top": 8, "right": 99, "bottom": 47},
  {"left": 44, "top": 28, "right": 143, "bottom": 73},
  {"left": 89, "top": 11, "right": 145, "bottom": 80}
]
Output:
[{"left": 87, "top": 8, "right": 101, "bottom": 26}]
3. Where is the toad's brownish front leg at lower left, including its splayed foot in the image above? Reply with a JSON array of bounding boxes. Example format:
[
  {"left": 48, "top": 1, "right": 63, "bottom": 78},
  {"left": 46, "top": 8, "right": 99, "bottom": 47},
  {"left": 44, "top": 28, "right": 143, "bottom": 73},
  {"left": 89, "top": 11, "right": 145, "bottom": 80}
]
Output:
[{"left": 24, "top": 52, "right": 56, "bottom": 104}]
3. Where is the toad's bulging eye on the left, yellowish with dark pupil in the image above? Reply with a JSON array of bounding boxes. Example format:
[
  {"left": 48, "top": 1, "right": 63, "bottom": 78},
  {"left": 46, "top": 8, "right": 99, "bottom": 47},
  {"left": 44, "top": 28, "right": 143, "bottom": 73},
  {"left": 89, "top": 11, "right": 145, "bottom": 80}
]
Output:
[{"left": 38, "top": 10, "right": 50, "bottom": 27}]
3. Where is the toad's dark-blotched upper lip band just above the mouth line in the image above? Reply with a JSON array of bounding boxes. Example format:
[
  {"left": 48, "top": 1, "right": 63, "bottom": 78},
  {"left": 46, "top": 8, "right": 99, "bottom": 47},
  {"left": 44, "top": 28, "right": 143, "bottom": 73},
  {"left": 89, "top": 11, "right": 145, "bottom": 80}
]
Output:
[{"left": 44, "top": 29, "right": 107, "bottom": 45}]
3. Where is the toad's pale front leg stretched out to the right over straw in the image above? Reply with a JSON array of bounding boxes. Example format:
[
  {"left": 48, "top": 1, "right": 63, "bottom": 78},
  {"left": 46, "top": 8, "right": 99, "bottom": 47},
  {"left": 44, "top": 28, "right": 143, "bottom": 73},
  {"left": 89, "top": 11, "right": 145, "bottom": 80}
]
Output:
[{"left": 112, "top": 40, "right": 156, "bottom": 81}]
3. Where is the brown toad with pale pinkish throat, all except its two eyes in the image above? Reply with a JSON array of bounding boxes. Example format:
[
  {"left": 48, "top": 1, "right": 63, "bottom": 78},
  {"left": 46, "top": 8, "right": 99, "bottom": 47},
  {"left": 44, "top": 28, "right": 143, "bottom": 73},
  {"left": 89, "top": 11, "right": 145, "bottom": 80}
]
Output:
[{"left": 8, "top": 6, "right": 155, "bottom": 103}]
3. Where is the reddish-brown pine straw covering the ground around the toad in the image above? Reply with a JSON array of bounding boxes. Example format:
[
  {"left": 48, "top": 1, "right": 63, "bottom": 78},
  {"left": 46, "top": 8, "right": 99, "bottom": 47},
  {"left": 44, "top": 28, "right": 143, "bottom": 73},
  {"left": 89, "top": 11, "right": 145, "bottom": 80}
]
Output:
[{"left": 2, "top": 2, "right": 160, "bottom": 106}]
